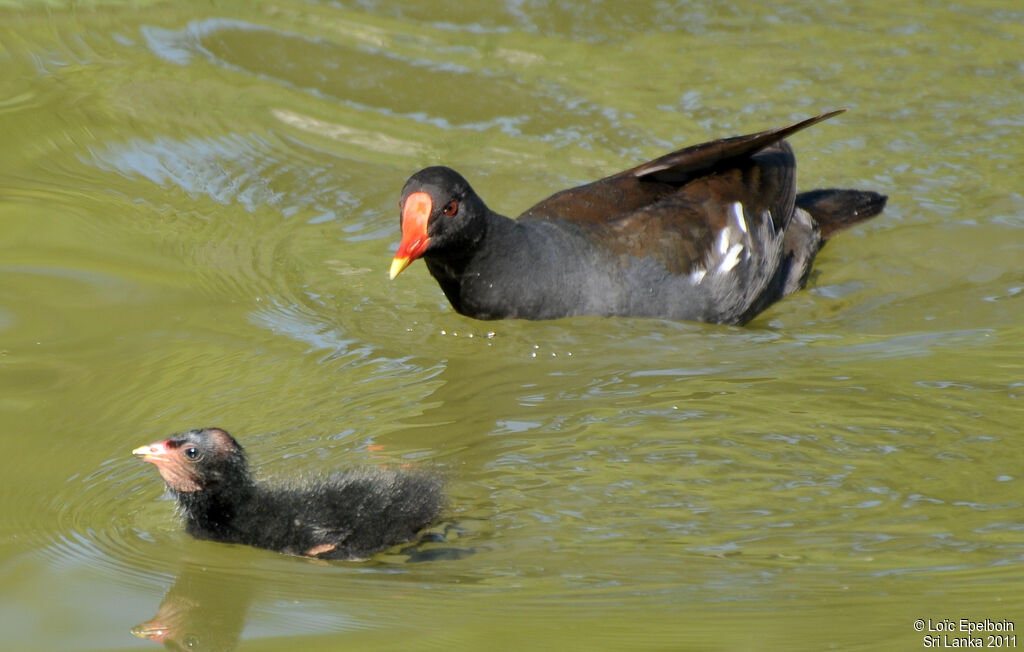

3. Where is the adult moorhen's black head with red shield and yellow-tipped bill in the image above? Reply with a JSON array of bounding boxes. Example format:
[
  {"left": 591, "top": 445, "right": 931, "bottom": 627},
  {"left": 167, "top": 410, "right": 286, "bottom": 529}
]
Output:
[{"left": 391, "top": 166, "right": 488, "bottom": 278}]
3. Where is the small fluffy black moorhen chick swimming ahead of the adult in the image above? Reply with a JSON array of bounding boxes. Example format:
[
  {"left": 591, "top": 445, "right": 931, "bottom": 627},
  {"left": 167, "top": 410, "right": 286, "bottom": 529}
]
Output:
[{"left": 132, "top": 428, "right": 443, "bottom": 560}]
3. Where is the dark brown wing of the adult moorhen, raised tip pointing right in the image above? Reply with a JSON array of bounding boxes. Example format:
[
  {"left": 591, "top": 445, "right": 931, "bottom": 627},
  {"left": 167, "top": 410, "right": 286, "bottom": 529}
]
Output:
[{"left": 520, "top": 111, "right": 842, "bottom": 273}]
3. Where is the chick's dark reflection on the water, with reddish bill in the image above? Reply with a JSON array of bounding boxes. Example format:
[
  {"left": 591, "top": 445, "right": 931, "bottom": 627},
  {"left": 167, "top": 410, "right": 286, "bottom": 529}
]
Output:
[{"left": 131, "top": 565, "right": 254, "bottom": 651}]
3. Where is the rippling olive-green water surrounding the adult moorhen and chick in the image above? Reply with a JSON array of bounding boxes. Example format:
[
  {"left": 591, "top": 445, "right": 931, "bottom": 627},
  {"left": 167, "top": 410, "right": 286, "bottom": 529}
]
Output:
[{"left": 0, "top": 0, "right": 1024, "bottom": 650}]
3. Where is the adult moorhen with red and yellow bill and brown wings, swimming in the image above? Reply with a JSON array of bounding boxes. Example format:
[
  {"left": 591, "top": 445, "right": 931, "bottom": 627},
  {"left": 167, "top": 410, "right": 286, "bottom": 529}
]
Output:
[{"left": 391, "top": 110, "right": 886, "bottom": 324}]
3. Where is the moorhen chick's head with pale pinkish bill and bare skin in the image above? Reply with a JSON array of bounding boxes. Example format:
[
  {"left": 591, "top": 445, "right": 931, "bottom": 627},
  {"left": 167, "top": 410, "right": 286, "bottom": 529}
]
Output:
[{"left": 132, "top": 428, "right": 251, "bottom": 493}]
